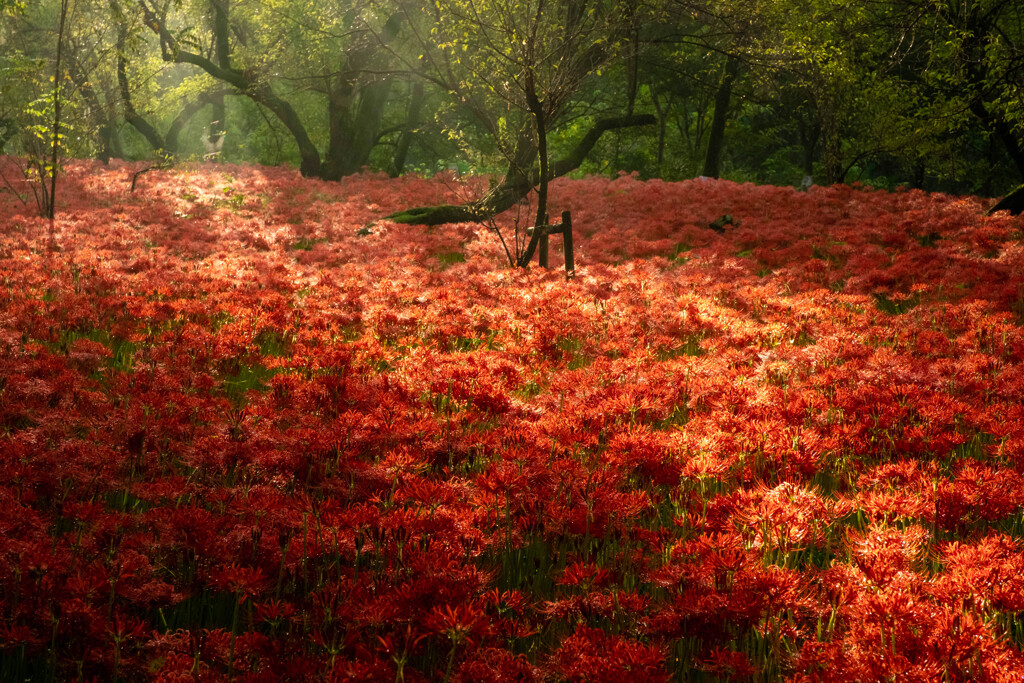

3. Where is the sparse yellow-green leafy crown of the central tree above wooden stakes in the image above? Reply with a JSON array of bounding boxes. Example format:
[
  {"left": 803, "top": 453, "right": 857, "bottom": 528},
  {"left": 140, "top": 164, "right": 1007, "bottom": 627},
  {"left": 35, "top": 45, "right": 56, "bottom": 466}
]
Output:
[{"left": 410, "top": 0, "right": 631, "bottom": 184}]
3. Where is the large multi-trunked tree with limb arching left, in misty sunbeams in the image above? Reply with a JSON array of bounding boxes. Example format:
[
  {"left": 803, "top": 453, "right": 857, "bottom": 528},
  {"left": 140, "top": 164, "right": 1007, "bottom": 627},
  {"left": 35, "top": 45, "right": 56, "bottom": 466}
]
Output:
[{"left": 133, "top": 0, "right": 423, "bottom": 179}]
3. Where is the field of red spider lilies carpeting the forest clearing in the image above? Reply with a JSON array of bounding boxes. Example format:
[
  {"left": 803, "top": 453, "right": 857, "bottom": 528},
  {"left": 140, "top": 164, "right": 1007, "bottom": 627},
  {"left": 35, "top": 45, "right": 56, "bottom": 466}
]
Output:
[{"left": 0, "top": 157, "right": 1024, "bottom": 683}]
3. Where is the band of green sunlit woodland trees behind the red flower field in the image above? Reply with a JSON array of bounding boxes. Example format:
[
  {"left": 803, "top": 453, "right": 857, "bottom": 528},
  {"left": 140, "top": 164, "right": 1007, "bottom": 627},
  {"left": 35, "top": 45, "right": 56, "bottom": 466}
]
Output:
[{"left": 0, "top": 0, "right": 1024, "bottom": 196}]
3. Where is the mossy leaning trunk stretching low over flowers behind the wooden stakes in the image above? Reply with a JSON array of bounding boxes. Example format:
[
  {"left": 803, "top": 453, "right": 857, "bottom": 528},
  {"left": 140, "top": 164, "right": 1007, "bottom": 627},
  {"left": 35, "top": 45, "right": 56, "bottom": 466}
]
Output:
[{"left": 387, "top": 114, "right": 657, "bottom": 225}]
